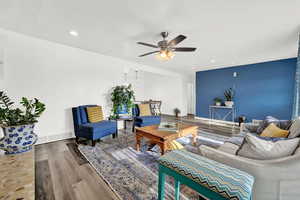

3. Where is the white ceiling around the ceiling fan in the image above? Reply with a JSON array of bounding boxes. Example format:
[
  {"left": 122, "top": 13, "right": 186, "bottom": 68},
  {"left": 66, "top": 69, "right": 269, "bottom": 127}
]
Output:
[{"left": 0, "top": 0, "right": 300, "bottom": 72}]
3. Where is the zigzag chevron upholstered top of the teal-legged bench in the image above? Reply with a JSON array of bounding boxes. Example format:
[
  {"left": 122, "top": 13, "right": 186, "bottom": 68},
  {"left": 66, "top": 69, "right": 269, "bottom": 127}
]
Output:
[{"left": 159, "top": 150, "right": 254, "bottom": 200}]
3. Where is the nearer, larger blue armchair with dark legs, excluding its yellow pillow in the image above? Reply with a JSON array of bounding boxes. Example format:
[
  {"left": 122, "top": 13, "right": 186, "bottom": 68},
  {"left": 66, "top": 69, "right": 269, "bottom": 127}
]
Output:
[{"left": 72, "top": 105, "right": 118, "bottom": 146}]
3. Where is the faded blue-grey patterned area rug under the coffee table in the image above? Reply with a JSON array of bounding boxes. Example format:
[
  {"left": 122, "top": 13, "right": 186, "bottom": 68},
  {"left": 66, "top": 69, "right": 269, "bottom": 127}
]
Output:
[{"left": 78, "top": 131, "right": 228, "bottom": 200}]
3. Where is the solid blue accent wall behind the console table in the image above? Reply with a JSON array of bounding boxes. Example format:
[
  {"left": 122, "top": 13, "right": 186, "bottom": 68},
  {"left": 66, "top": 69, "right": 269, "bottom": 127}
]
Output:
[{"left": 196, "top": 58, "right": 297, "bottom": 121}]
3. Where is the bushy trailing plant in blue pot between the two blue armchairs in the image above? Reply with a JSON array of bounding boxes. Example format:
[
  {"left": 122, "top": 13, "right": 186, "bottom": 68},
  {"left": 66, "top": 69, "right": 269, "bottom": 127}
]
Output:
[{"left": 110, "top": 84, "right": 135, "bottom": 119}]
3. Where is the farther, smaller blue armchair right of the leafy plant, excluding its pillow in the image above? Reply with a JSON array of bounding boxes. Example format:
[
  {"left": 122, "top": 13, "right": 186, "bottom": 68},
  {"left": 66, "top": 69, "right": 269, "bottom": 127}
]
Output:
[{"left": 132, "top": 104, "right": 161, "bottom": 131}]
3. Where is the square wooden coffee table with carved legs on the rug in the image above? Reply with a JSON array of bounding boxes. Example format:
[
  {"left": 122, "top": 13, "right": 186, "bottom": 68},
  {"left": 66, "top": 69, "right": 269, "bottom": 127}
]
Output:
[{"left": 136, "top": 123, "right": 198, "bottom": 155}]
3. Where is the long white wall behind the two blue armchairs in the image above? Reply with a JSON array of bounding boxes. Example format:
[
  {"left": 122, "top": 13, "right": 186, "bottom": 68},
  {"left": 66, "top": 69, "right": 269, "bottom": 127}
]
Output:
[{"left": 0, "top": 29, "right": 188, "bottom": 142}]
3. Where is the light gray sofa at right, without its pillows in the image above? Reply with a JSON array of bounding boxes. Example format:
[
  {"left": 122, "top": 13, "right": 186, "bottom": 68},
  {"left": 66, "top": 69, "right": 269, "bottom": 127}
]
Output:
[{"left": 199, "top": 121, "right": 300, "bottom": 200}]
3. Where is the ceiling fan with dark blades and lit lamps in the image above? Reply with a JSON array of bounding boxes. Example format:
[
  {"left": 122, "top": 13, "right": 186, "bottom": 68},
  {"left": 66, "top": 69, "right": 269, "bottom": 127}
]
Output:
[{"left": 138, "top": 32, "right": 196, "bottom": 60}]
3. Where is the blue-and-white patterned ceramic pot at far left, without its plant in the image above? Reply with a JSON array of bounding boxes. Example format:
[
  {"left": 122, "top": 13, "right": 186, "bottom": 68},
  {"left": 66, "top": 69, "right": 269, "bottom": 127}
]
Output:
[{"left": 0, "top": 124, "right": 37, "bottom": 154}]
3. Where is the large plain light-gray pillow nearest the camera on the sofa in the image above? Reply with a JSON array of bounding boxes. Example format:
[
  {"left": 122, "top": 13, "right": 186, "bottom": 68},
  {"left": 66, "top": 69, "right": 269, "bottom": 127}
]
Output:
[{"left": 237, "top": 134, "right": 300, "bottom": 160}]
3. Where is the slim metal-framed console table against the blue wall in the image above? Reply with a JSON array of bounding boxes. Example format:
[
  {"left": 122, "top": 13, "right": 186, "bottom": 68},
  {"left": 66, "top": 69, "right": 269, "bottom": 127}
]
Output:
[{"left": 209, "top": 106, "right": 236, "bottom": 122}]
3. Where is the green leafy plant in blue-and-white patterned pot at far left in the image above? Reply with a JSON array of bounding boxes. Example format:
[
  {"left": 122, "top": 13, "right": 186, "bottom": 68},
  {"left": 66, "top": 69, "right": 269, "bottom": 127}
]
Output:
[{"left": 0, "top": 91, "right": 45, "bottom": 154}]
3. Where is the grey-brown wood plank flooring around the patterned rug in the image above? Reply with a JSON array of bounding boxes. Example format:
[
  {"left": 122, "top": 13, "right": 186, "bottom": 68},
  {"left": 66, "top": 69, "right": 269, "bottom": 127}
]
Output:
[{"left": 35, "top": 116, "right": 237, "bottom": 200}]
